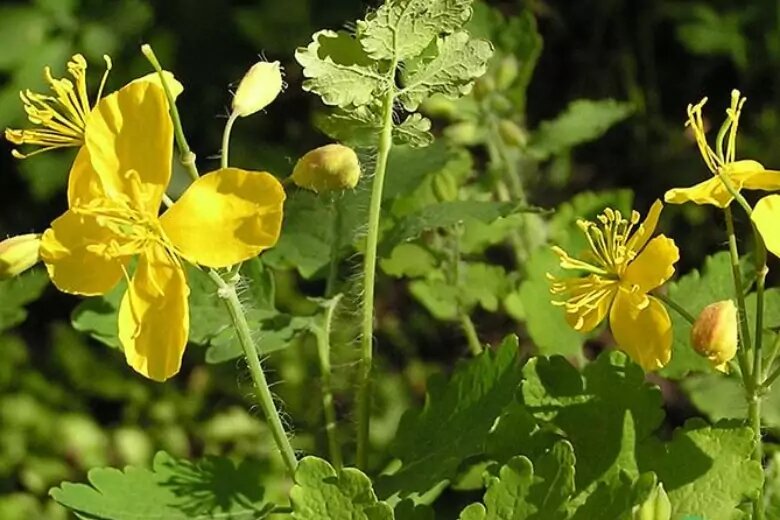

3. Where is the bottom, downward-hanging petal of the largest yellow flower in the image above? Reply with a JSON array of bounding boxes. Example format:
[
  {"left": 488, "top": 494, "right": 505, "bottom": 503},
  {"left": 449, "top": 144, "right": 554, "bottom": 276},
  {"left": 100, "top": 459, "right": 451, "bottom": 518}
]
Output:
[{"left": 119, "top": 245, "right": 190, "bottom": 381}]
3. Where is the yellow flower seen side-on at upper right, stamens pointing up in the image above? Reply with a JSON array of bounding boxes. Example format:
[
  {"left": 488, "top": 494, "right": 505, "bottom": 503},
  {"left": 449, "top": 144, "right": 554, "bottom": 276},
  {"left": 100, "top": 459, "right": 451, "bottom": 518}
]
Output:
[{"left": 664, "top": 90, "right": 780, "bottom": 208}]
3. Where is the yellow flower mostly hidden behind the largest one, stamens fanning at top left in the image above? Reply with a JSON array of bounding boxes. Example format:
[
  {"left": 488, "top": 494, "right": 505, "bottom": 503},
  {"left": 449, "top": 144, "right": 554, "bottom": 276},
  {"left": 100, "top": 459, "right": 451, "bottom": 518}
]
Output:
[{"left": 5, "top": 54, "right": 182, "bottom": 159}]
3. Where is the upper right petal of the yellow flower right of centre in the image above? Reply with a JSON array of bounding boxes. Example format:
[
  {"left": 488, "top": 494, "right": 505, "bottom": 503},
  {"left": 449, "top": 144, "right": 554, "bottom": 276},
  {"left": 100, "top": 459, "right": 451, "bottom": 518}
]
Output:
[{"left": 621, "top": 235, "right": 680, "bottom": 294}]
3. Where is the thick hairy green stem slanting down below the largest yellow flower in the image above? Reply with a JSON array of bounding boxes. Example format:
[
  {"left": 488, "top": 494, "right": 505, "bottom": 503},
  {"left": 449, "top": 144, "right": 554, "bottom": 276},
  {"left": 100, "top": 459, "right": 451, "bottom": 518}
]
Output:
[{"left": 209, "top": 270, "right": 298, "bottom": 476}]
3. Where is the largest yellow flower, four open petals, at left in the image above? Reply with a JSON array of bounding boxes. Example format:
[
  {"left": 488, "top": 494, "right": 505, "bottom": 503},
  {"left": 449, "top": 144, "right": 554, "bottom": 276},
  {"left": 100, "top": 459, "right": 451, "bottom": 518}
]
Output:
[{"left": 41, "top": 81, "right": 284, "bottom": 381}]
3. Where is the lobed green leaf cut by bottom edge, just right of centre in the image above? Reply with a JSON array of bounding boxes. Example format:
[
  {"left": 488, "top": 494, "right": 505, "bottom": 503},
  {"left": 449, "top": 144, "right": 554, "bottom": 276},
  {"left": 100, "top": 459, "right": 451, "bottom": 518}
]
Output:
[{"left": 460, "top": 441, "right": 574, "bottom": 520}]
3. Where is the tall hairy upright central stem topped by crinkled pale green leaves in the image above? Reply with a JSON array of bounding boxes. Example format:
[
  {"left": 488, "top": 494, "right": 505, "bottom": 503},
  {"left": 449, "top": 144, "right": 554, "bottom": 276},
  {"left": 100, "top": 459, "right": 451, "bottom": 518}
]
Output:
[{"left": 356, "top": 82, "right": 397, "bottom": 469}]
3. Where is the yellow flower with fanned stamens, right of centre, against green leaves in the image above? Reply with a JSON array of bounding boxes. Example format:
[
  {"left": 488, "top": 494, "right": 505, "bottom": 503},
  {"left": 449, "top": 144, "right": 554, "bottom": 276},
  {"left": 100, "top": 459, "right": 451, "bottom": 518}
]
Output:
[{"left": 548, "top": 201, "right": 680, "bottom": 371}]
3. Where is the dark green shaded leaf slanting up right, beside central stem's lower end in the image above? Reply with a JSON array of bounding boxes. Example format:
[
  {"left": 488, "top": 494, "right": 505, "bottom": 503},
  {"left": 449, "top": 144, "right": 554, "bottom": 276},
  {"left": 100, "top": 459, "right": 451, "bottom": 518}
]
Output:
[{"left": 378, "top": 336, "right": 520, "bottom": 497}]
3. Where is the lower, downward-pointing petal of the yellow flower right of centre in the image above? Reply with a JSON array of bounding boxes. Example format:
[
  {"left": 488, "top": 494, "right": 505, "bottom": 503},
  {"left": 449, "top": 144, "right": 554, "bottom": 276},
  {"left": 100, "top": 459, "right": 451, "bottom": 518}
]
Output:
[{"left": 609, "top": 289, "right": 672, "bottom": 372}]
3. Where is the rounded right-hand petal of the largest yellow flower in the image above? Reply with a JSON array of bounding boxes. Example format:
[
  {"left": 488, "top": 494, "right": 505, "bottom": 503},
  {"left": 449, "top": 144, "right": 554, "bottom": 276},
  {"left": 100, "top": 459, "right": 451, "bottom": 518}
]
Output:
[{"left": 160, "top": 168, "right": 285, "bottom": 267}]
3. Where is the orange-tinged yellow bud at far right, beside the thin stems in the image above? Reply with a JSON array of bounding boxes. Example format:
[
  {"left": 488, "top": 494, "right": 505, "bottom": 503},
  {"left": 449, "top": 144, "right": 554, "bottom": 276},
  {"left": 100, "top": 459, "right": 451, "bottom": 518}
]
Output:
[{"left": 691, "top": 300, "right": 739, "bottom": 372}]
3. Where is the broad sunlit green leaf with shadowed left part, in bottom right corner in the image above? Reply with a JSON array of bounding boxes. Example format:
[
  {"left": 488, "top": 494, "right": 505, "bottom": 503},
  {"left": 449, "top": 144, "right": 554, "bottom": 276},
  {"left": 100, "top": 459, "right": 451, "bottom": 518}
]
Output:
[{"left": 643, "top": 419, "right": 764, "bottom": 520}]
